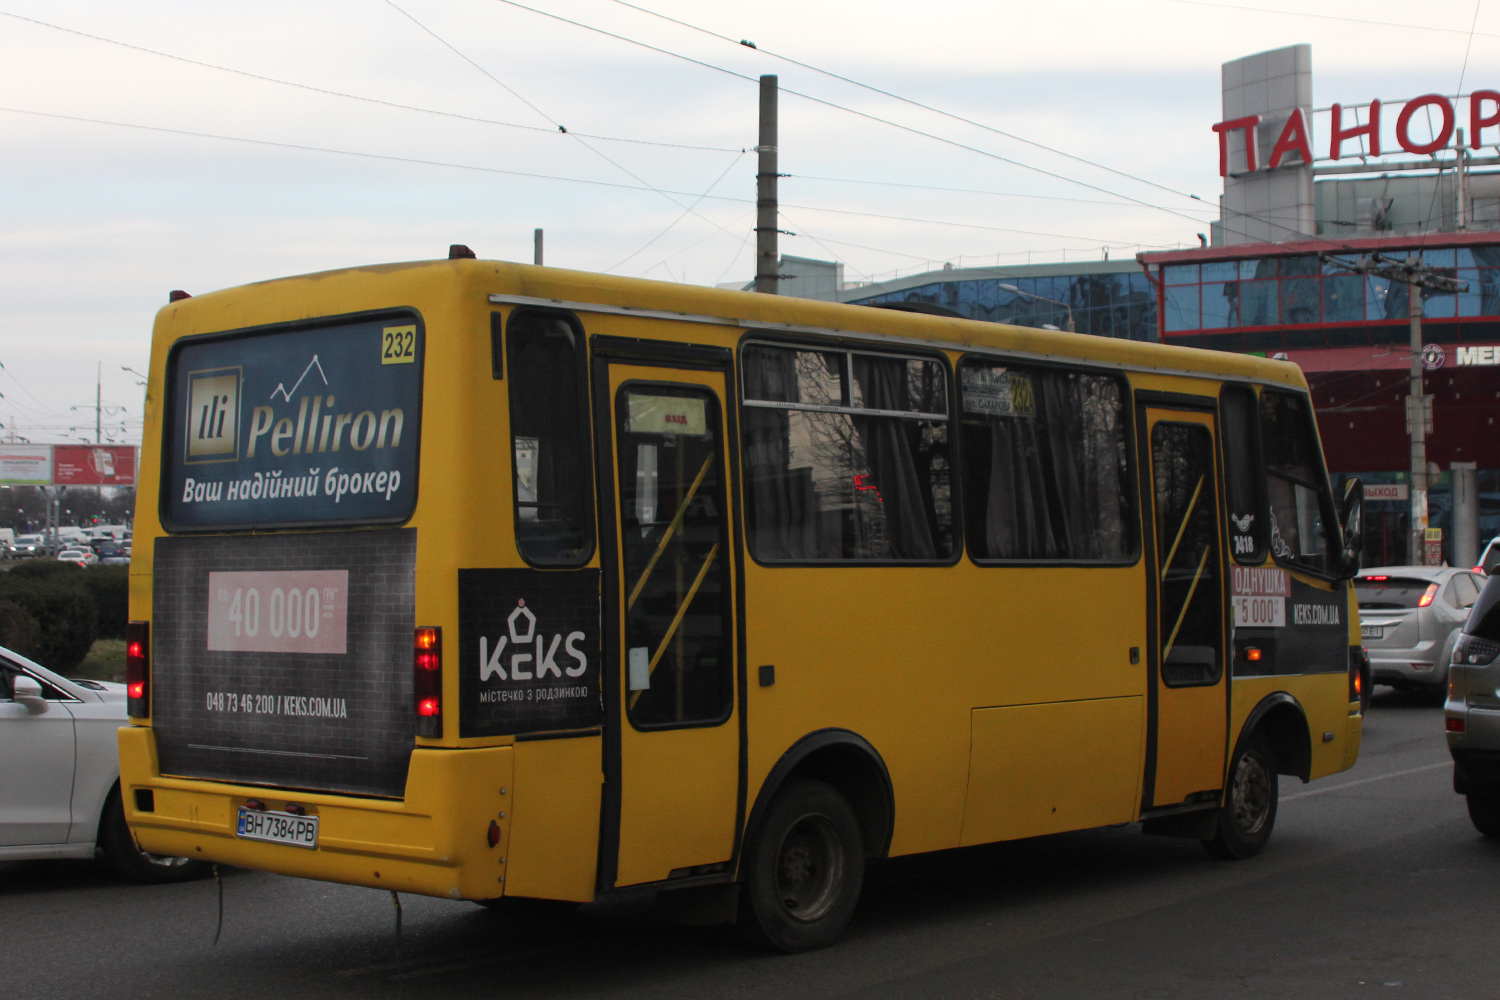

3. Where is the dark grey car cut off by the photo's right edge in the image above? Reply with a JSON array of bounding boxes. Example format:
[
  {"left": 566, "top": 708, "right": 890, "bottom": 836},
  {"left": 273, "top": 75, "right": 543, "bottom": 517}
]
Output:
[{"left": 1443, "top": 576, "right": 1500, "bottom": 838}]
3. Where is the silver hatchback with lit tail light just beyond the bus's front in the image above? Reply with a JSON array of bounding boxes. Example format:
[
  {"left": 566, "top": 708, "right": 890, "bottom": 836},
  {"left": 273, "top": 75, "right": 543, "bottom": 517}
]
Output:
[{"left": 1355, "top": 567, "right": 1485, "bottom": 696}]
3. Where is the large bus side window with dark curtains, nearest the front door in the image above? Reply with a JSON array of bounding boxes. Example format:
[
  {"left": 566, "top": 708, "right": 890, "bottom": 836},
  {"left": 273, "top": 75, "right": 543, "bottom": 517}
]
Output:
[{"left": 960, "top": 358, "right": 1136, "bottom": 562}]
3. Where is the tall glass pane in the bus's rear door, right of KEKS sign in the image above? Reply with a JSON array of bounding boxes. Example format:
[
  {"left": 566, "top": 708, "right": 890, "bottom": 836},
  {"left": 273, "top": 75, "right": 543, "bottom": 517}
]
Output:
[{"left": 618, "top": 387, "right": 734, "bottom": 727}]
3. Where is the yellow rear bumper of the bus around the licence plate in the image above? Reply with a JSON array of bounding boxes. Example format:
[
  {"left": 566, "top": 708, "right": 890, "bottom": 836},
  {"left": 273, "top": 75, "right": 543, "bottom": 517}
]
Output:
[{"left": 120, "top": 726, "right": 513, "bottom": 900}]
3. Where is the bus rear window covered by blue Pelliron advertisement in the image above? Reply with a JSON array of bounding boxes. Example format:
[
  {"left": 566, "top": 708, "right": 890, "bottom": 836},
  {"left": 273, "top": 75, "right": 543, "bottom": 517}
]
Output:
[{"left": 161, "top": 310, "right": 423, "bottom": 531}]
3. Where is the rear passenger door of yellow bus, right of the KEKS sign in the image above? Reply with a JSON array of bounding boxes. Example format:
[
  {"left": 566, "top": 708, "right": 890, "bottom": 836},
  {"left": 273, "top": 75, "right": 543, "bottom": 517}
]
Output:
[{"left": 594, "top": 351, "right": 741, "bottom": 889}]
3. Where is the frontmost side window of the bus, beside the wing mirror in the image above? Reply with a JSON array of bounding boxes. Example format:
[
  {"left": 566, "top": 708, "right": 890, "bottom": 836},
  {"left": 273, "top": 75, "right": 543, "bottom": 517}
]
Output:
[{"left": 1260, "top": 390, "right": 1335, "bottom": 573}]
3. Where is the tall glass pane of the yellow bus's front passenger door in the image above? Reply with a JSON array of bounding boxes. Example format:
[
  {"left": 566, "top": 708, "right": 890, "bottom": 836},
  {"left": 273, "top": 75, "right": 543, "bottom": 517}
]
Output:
[{"left": 1151, "top": 421, "right": 1223, "bottom": 687}]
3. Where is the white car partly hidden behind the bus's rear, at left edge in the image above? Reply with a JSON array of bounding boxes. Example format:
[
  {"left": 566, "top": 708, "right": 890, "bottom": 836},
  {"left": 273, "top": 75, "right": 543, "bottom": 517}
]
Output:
[{"left": 0, "top": 648, "right": 209, "bottom": 882}]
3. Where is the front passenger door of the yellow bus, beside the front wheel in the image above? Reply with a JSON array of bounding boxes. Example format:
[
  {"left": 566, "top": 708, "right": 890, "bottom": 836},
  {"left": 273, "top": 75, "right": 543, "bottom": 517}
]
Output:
[{"left": 1139, "top": 406, "right": 1229, "bottom": 810}]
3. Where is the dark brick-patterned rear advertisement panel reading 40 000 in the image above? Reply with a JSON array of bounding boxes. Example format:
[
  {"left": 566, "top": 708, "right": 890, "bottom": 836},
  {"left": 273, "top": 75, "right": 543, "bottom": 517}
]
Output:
[{"left": 152, "top": 528, "right": 417, "bottom": 798}]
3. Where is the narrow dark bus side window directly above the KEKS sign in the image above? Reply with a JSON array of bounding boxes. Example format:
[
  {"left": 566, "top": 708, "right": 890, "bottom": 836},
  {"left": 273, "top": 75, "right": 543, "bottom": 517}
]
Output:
[{"left": 506, "top": 310, "right": 594, "bottom": 565}]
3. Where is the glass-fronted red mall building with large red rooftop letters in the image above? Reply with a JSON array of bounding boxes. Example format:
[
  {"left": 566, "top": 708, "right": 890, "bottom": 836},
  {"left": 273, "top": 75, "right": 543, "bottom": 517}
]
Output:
[{"left": 786, "top": 45, "right": 1500, "bottom": 565}]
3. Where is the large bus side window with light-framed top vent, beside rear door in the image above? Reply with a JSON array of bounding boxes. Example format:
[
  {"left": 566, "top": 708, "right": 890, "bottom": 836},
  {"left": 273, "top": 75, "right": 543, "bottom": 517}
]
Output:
[{"left": 743, "top": 343, "right": 954, "bottom": 562}]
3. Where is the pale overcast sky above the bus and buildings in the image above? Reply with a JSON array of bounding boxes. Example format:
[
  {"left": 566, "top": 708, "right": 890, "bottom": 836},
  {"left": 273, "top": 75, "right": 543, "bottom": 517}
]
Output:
[{"left": 0, "top": 0, "right": 1500, "bottom": 441}]
